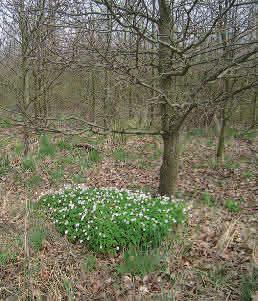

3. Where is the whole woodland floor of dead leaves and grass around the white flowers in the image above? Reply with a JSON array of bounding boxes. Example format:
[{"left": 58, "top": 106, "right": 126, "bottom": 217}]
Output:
[{"left": 0, "top": 128, "right": 258, "bottom": 301}]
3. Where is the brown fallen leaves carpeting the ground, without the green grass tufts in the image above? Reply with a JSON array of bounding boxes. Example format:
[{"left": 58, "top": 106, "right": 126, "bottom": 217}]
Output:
[{"left": 0, "top": 127, "right": 258, "bottom": 301}]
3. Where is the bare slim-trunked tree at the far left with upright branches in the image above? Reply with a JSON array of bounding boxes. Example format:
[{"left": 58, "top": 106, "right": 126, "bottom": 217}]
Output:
[{"left": 0, "top": 0, "right": 77, "bottom": 155}]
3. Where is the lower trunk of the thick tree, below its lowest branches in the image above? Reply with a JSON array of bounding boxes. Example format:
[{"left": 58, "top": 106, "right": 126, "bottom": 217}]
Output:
[{"left": 159, "top": 131, "right": 180, "bottom": 196}]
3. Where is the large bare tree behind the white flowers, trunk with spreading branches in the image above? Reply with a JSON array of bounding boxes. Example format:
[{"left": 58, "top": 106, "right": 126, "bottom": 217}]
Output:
[{"left": 73, "top": 0, "right": 256, "bottom": 195}]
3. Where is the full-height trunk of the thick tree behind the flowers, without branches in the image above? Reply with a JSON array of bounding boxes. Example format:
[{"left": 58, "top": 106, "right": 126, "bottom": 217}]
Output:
[{"left": 158, "top": 0, "right": 180, "bottom": 196}]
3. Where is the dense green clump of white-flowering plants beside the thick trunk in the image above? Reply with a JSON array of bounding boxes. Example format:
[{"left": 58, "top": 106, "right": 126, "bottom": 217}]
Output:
[{"left": 41, "top": 187, "right": 186, "bottom": 253}]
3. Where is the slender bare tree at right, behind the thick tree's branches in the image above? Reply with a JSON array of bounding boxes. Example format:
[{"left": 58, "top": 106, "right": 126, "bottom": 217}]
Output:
[{"left": 216, "top": 0, "right": 255, "bottom": 164}]
